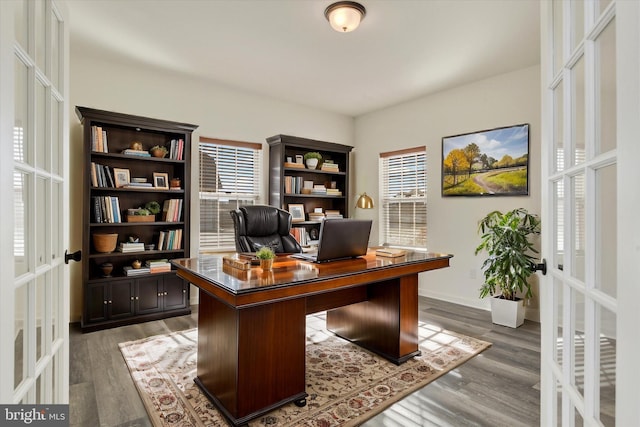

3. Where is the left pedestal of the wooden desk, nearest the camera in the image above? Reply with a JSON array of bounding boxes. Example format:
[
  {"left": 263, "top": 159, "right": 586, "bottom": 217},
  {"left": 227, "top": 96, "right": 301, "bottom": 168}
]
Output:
[{"left": 197, "top": 291, "right": 306, "bottom": 425}]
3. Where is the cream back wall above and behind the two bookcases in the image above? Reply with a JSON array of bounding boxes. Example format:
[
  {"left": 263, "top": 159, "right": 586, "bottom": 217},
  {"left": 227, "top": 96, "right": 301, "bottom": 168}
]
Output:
[{"left": 70, "top": 51, "right": 354, "bottom": 321}]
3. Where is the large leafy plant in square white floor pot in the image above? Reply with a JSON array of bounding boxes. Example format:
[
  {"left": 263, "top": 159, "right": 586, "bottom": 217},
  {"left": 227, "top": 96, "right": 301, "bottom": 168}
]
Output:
[{"left": 475, "top": 208, "right": 540, "bottom": 328}]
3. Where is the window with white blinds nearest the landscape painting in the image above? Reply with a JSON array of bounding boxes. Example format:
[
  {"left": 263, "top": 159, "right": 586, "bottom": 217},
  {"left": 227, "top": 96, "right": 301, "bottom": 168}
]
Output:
[{"left": 380, "top": 147, "right": 427, "bottom": 249}]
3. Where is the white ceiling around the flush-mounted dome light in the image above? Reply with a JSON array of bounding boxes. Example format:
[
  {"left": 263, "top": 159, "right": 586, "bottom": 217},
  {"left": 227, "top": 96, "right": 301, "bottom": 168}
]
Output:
[{"left": 65, "top": 0, "right": 540, "bottom": 116}]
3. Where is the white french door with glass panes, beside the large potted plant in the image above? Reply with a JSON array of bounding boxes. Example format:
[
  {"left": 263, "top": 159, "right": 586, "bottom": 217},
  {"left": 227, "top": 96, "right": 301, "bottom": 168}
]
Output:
[{"left": 541, "top": 0, "right": 640, "bottom": 427}]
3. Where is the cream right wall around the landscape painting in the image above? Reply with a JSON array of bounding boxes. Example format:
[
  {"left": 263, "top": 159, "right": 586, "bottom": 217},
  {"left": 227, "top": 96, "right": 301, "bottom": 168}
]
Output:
[{"left": 353, "top": 66, "right": 541, "bottom": 320}]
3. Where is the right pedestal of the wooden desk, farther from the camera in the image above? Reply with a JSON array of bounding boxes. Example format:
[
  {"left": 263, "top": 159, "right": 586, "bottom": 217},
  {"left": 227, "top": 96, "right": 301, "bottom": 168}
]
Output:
[{"left": 327, "top": 274, "right": 420, "bottom": 364}]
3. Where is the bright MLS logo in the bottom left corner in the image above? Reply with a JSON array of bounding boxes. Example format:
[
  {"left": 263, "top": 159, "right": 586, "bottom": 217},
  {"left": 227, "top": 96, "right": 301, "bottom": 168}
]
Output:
[{"left": 0, "top": 405, "right": 69, "bottom": 427}]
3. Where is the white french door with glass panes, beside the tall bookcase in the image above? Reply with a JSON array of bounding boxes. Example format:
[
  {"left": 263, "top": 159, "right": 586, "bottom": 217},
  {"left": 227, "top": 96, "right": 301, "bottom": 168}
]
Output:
[{"left": 0, "top": 0, "right": 69, "bottom": 404}]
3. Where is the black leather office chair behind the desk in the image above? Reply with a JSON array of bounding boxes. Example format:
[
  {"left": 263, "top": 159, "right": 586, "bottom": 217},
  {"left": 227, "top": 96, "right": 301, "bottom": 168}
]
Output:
[{"left": 230, "top": 205, "right": 302, "bottom": 253}]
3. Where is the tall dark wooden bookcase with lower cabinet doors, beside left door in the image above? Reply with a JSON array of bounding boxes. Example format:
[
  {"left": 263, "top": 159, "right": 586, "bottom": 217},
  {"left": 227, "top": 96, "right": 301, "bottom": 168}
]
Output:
[{"left": 76, "top": 107, "right": 197, "bottom": 331}]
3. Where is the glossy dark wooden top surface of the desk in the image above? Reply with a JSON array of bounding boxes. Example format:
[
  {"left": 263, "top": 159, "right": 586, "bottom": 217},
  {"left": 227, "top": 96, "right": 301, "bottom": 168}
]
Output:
[{"left": 172, "top": 249, "right": 452, "bottom": 295}]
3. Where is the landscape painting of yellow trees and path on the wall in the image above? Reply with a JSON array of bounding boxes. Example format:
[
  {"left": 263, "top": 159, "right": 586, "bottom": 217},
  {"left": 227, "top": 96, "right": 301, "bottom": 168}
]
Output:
[{"left": 442, "top": 124, "right": 529, "bottom": 196}]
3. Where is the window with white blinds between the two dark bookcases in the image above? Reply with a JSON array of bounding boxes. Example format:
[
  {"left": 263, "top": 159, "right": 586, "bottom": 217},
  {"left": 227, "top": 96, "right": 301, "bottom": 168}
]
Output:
[{"left": 199, "top": 137, "right": 262, "bottom": 252}]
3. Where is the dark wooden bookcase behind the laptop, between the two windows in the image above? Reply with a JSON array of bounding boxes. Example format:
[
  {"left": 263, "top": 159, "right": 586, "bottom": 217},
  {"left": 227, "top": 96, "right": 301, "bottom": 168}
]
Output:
[{"left": 267, "top": 135, "right": 353, "bottom": 244}]
